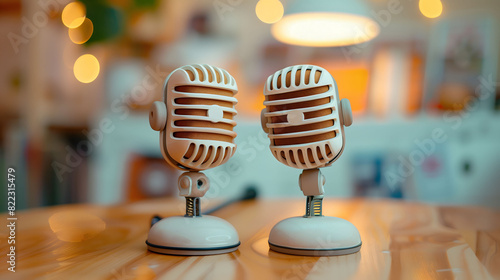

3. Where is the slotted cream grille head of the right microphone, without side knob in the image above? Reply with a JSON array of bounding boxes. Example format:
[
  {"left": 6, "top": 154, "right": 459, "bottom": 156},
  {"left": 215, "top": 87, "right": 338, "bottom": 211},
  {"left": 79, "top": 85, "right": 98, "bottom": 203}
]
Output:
[{"left": 264, "top": 65, "right": 343, "bottom": 169}]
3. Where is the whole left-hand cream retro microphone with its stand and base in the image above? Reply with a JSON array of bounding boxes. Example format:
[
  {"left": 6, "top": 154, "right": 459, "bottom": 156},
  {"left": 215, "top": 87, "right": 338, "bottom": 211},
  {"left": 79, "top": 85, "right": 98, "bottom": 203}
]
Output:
[{"left": 146, "top": 64, "right": 240, "bottom": 255}]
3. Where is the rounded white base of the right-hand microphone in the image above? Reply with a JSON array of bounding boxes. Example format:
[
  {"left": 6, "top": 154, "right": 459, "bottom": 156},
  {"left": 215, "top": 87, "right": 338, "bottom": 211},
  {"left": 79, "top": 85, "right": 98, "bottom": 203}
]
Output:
[{"left": 269, "top": 216, "right": 361, "bottom": 256}]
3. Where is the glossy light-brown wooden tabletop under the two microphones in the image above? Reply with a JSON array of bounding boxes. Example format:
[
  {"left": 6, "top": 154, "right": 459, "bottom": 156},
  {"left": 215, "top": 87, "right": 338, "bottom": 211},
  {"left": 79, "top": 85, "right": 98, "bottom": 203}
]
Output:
[{"left": 0, "top": 199, "right": 500, "bottom": 280}]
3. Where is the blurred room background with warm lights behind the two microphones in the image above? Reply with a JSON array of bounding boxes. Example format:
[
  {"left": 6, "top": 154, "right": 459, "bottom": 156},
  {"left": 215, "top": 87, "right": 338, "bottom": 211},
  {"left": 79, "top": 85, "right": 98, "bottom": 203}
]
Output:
[{"left": 0, "top": 0, "right": 500, "bottom": 211}]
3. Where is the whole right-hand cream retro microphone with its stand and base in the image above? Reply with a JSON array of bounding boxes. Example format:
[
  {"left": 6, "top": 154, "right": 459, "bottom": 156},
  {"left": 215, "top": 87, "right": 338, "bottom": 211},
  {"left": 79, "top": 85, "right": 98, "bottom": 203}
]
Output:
[{"left": 261, "top": 65, "right": 361, "bottom": 256}]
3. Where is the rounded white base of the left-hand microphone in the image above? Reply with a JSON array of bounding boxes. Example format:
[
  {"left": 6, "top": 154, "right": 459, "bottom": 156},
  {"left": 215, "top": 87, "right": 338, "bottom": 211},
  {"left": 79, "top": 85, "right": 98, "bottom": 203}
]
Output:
[{"left": 146, "top": 215, "right": 240, "bottom": 256}]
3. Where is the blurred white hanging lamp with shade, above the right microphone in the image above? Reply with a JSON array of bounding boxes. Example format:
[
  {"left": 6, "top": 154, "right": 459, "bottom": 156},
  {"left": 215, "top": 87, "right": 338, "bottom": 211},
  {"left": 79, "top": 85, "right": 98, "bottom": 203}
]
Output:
[{"left": 271, "top": 0, "right": 380, "bottom": 47}]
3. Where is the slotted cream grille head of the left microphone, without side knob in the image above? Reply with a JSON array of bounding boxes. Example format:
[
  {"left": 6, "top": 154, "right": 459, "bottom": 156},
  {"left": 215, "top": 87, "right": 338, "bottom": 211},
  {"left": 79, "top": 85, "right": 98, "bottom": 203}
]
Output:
[{"left": 165, "top": 64, "right": 238, "bottom": 170}]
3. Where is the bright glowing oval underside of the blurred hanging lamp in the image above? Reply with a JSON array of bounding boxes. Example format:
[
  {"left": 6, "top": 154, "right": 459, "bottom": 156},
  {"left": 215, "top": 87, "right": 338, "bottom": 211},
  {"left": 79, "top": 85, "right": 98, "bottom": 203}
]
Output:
[{"left": 271, "top": 12, "right": 380, "bottom": 47}]
